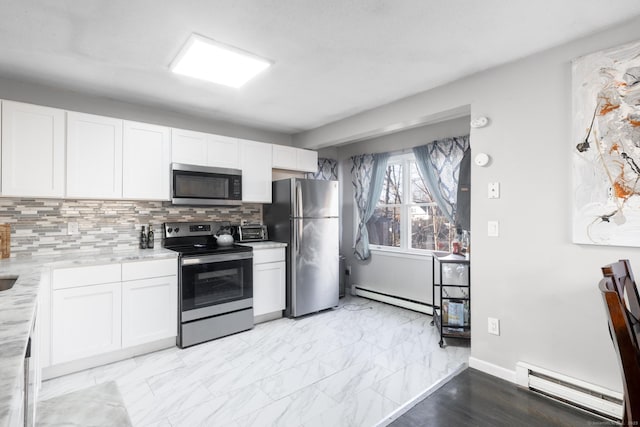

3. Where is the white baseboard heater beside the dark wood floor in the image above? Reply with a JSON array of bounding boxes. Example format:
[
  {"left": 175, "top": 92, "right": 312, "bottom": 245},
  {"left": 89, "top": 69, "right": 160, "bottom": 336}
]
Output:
[{"left": 516, "top": 362, "right": 623, "bottom": 422}]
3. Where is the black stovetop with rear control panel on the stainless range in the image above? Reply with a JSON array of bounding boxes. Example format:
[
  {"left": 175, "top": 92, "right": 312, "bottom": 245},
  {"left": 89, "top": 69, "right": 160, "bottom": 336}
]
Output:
[{"left": 163, "top": 221, "right": 253, "bottom": 255}]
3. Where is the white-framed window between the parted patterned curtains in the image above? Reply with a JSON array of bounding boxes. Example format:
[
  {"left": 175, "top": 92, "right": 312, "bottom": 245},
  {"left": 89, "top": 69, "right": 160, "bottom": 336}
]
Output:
[{"left": 367, "top": 154, "right": 455, "bottom": 251}]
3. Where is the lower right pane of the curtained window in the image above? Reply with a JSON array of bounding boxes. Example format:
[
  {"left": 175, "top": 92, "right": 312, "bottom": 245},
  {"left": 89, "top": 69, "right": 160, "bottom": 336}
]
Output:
[{"left": 410, "top": 205, "right": 455, "bottom": 251}]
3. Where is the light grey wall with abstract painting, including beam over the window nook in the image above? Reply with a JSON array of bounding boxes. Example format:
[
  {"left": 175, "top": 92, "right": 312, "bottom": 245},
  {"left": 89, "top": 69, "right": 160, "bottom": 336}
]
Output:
[{"left": 294, "top": 18, "right": 640, "bottom": 391}]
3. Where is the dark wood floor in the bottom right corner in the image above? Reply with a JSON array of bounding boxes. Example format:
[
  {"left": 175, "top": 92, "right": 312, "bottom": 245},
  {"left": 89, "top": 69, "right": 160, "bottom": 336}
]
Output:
[{"left": 391, "top": 368, "right": 616, "bottom": 427}]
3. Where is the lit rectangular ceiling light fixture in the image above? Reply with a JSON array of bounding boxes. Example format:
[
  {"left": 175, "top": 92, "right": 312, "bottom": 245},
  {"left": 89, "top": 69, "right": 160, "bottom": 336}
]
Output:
[{"left": 170, "top": 34, "right": 271, "bottom": 88}]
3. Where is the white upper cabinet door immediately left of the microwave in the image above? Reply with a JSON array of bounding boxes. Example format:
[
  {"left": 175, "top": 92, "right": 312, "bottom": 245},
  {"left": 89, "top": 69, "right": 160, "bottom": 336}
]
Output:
[{"left": 122, "top": 121, "right": 171, "bottom": 200}]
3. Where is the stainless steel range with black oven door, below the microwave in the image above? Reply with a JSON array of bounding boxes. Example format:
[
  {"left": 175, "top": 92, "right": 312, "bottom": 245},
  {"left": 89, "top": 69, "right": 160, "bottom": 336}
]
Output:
[{"left": 164, "top": 222, "right": 253, "bottom": 348}]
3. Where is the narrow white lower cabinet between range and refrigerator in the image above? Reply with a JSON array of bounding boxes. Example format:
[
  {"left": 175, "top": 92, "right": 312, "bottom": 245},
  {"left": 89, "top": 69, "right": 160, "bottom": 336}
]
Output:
[{"left": 253, "top": 247, "right": 286, "bottom": 317}]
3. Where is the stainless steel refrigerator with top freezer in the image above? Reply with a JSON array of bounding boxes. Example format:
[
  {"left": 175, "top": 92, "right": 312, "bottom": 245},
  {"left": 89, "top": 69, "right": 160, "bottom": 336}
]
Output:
[{"left": 264, "top": 178, "right": 340, "bottom": 317}]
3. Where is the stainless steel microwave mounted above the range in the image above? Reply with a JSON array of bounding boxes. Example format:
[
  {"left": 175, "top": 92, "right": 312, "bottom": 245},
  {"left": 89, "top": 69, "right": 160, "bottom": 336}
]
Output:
[{"left": 171, "top": 163, "right": 242, "bottom": 206}]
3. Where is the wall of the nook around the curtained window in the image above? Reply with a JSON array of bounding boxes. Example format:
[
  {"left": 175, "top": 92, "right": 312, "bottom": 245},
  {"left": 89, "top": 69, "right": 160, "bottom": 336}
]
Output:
[{"left": 338, "top": 117, "right": 469, "bottom": 304}]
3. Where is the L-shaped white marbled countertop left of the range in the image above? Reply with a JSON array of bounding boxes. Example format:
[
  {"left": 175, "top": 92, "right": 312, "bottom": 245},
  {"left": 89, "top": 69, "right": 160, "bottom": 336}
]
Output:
[{"left": 0, "top": 248, "right": 178, "bottom": 427}]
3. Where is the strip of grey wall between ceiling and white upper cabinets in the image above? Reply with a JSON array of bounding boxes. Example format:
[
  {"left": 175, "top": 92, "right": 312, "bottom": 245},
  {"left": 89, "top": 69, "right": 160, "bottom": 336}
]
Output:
[{"left": 0, "top": 77, "right": 291, "bottom": 145}]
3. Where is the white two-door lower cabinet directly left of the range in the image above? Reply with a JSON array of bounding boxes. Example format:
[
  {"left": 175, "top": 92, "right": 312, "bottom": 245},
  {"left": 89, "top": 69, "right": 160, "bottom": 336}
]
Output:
[{"left": 45, "top": 258, "right": 178, "bottom": 368}]
